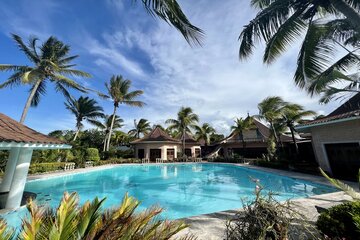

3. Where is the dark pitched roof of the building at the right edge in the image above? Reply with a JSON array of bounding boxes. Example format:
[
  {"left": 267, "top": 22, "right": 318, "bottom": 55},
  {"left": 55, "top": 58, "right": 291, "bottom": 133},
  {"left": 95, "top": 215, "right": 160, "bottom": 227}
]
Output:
[{"left": 296, "top": 93, "right": 360, "bottom": 129}]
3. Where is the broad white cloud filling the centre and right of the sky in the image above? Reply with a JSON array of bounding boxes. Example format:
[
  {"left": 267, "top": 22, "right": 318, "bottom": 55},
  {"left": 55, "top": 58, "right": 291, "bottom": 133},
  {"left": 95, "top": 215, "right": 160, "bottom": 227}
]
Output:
[{"left": 99, "top": 0, "right": 340, "bottom": 133}]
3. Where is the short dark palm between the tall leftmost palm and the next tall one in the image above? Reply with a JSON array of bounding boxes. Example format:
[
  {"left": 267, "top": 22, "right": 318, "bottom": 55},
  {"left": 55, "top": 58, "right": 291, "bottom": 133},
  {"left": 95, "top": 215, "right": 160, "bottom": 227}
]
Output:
[{"left": 65, "top": 96, "right": 105, "bottom": 141}]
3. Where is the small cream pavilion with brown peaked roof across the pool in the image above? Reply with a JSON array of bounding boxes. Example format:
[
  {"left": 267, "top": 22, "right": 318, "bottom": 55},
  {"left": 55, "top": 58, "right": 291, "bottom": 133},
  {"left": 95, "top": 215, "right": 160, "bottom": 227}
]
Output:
[{"left": 130, "top": 127, "right": 201, "bottom": 161}]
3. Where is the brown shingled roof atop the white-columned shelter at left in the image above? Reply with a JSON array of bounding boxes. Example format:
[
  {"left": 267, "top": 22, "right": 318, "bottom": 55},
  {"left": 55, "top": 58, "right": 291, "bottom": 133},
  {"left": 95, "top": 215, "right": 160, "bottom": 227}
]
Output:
[{"left": 0, "top": 113, "right": 65, "bottom": 144}]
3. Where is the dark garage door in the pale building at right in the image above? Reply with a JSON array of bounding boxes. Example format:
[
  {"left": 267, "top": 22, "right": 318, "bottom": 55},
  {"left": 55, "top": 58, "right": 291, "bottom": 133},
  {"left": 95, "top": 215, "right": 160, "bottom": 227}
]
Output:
[{"left": 325, "top": 143, "right": 360, "bottom": 181}]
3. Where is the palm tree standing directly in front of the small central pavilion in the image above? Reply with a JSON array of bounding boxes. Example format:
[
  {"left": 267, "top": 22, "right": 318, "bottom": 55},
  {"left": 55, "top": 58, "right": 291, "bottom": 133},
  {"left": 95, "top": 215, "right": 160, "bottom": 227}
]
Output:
[{"left": 165, "top": 107, "right": 199, "bottom": 157}]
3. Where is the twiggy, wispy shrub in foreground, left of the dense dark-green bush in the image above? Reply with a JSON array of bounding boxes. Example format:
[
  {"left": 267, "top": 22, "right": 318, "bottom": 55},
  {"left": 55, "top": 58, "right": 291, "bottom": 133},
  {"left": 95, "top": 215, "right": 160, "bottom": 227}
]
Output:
[{"left": 225, "top": 183, "right": 313, "bottom": 240}]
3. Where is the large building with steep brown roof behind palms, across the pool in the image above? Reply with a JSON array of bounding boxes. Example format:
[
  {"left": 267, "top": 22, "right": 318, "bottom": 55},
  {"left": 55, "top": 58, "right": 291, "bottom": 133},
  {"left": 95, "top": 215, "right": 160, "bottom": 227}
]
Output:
[{"left": 208, "top": 118, "right": 304, "bottom": 158}]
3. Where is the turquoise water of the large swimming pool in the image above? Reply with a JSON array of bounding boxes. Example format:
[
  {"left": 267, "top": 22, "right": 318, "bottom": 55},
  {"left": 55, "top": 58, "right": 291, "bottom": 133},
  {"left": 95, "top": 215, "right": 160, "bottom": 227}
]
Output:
[{"left": 3, "top": 164, "right": 336, "bottom": 226}]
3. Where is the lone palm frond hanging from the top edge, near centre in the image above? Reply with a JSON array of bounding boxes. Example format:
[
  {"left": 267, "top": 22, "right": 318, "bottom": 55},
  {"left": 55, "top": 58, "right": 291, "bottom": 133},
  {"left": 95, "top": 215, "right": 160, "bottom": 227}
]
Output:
[{"left": 136, "top": 0, "right": 204, "bottom": 45}]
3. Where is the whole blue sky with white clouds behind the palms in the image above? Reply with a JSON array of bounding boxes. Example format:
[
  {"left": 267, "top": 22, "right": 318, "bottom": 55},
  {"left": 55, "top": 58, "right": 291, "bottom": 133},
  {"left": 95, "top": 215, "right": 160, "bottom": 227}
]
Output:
[{"left": 0, "top": 0, "right": 339, "bottom": 134}]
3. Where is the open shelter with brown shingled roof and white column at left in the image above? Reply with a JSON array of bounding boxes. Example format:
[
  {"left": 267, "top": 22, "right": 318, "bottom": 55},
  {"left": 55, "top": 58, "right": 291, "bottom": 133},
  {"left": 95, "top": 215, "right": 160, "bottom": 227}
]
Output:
[{"left": 0, "top": 113, "right": 71, "bottom": 209}]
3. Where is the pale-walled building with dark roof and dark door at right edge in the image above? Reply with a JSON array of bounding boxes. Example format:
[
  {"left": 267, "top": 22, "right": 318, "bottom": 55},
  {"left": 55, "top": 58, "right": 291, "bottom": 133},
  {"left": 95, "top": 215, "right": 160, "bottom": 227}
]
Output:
[{"left": 296, "top": 93, "right": 360, "bottom": 180}]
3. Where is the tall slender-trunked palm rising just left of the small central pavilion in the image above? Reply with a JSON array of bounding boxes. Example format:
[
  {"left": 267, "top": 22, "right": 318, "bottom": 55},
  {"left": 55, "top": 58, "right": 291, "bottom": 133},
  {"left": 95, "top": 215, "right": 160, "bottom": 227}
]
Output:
[{"left": 103, "top": 75, "right": 144, "bottom": 151}]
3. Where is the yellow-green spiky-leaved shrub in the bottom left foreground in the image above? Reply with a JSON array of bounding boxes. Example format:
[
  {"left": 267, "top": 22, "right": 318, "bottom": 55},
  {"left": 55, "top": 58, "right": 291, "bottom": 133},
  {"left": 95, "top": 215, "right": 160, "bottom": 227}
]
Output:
[{"left": 0, "top": 193, "right": 195, "bottom": 240}]
